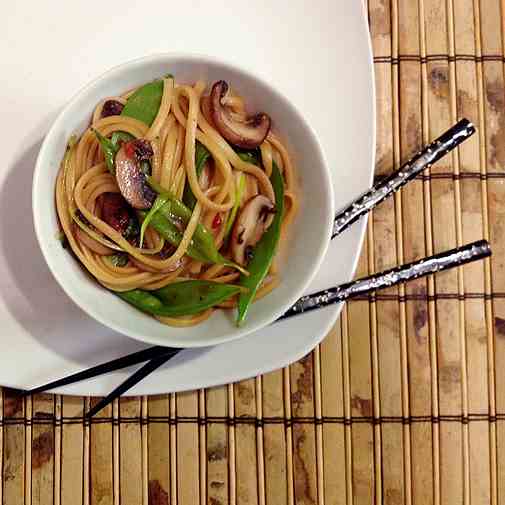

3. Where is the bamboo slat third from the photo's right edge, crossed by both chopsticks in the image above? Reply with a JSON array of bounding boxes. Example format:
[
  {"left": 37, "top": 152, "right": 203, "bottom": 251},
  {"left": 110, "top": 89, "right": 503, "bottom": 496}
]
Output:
[{"left": 421, "top": 0, "right": 469, "bottom": 503}]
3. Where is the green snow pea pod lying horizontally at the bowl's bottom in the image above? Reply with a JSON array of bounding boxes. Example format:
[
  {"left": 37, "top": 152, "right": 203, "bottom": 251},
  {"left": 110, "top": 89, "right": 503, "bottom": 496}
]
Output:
[{"left": 116, "top": 280, "right": 241, "bottom": 317}]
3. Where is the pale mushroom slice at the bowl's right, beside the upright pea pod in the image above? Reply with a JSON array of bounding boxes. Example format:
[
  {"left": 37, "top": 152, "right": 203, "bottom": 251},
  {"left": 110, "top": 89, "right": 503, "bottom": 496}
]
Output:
[{"left": 231, "top": 195, "right": 274, "bottom": 265}]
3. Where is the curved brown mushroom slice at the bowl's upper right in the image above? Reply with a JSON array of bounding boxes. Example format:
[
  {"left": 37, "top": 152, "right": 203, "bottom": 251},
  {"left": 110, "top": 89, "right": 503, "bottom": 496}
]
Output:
[{"left": 210, "top": 81, "right": 271, "bottom": 149}]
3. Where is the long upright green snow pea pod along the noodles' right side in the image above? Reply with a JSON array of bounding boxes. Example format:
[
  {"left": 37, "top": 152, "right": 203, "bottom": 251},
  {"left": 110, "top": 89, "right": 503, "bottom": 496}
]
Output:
[{"left": 237, "top": 162, "right": 284, "bottom": 326}]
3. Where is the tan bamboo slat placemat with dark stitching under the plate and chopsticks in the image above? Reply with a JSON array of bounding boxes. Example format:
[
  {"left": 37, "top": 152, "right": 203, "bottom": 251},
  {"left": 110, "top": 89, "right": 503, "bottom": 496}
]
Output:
[{"left": 0, "top": 0, "right": 505, "bottom": 505}]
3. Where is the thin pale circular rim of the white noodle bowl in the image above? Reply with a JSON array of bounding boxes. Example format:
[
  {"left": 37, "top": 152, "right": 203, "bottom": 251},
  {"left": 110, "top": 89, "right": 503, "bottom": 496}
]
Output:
[{"left": 32, "top": 51, "right": 335, "bottom": 348}]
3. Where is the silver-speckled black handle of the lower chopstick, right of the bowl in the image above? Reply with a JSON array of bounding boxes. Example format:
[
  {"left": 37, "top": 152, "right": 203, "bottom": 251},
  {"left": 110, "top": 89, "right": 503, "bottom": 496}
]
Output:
[{"left": 279, "top": 240, "right": 491, "bottom": 319}]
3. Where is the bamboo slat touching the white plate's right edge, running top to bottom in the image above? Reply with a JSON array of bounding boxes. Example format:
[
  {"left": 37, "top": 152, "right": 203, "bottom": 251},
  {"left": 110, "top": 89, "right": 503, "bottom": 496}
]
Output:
[{"left": 368, "top": 2, "right": 404, "bottom": 494}]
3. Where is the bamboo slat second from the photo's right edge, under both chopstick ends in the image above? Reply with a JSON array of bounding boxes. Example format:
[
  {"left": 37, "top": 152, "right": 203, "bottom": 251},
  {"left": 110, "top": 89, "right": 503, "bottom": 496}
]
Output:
[{"left": 449, "top": 2, "right": 491, "bottom": 503}]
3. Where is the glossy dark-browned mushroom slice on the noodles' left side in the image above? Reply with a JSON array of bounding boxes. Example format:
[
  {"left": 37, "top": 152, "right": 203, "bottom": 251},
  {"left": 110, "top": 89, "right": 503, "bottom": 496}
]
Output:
[{"left": 115, "top": 139, "right": 156, "bottom": 209}]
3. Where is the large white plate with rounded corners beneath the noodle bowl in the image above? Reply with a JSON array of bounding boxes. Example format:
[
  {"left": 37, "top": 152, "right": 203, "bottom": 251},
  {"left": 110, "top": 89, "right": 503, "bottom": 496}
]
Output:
[{"left": 0, "top": 0, "right": 375, "bottom": 395}]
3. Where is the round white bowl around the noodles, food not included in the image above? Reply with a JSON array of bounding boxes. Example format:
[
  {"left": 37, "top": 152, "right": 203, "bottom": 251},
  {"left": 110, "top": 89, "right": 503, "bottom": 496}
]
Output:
[{"left": 32, "top": 54, "right": 334, "bottom": 347}]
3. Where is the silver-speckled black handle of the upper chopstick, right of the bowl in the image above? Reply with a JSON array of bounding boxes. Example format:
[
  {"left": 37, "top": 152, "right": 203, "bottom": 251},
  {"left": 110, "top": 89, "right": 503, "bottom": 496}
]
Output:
[{"left": 331, "top": 119, "right": 475, "bottom": 238}]
